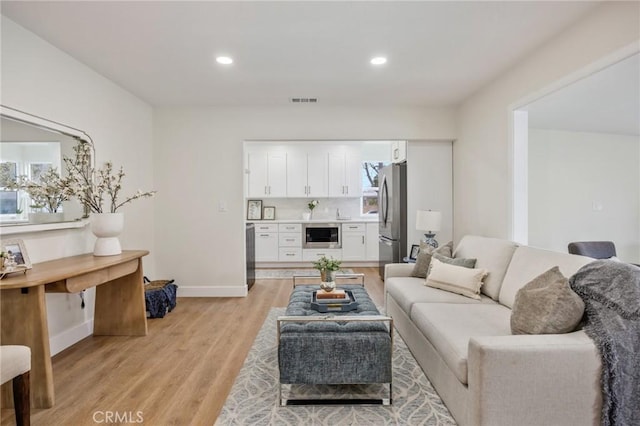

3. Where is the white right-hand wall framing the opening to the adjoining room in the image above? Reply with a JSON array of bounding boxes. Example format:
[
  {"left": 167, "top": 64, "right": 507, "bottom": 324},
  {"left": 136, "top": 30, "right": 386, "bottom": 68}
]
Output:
[{"left": 453, "top": 2, "right": 640, "bottom": 240}]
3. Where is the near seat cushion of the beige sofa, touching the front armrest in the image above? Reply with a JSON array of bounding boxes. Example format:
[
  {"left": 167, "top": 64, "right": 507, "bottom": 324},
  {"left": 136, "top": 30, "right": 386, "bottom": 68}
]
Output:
[{"left": 411, "top": 301, "right": 511, "bottom": 385}]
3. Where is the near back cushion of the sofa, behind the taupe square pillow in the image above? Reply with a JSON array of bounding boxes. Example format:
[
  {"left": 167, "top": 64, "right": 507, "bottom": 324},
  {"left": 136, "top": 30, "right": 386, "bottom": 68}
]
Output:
[{"left": 499, "top": 246, "right": 594, "bottom": 308}]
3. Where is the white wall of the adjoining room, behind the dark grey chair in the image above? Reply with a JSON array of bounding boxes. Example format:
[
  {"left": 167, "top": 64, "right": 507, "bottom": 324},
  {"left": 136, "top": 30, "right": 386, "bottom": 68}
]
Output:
[{"left": 529, "top": 129, "right": 640, "bottom": 263}]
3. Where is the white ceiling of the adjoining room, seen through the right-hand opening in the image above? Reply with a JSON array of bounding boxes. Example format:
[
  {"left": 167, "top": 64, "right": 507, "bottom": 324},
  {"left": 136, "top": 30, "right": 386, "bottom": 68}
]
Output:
[{"left": 523, "top": 55, "right": 640, "bottom": 135}]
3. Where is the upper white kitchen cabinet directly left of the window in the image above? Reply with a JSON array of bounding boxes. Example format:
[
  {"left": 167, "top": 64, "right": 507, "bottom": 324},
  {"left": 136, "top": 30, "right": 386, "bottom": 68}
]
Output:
[{"left": 329, "top": 145, "right": 362, "bottom": 197}]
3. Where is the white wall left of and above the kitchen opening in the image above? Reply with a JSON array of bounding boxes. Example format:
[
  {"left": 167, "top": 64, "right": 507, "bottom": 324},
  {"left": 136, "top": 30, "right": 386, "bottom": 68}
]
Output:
[{"left": 153, "top": 105, "right": 454, "bottom": 296}]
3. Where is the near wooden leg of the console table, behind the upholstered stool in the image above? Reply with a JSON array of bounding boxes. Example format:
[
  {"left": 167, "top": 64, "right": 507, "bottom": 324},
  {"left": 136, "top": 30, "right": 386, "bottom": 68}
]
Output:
[{"left": 0, "top": 286, "right": 54, "bottom": 408}]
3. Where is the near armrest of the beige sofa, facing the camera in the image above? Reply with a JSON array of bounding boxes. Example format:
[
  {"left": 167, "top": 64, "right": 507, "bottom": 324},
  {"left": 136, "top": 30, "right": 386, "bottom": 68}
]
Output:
[{"left": 468, "top": 331, "right": 602, "bottom": 425}]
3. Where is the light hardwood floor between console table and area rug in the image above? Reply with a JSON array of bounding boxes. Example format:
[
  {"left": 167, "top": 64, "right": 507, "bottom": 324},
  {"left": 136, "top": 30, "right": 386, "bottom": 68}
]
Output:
[{"left": 2, "top": 268, "right": 383, "bottom": 426}]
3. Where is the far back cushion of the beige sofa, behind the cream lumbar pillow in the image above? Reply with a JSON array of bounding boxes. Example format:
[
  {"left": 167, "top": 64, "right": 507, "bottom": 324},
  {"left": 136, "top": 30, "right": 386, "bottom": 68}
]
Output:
[{"left": 453, "top": 235, "right": 518, "bottom": 300}]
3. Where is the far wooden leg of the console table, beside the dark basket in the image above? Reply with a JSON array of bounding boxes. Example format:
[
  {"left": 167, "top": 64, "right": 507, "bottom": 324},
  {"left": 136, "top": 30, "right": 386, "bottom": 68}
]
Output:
[{"left": 93, "top": 259, "right": 147, "bottom": 336}]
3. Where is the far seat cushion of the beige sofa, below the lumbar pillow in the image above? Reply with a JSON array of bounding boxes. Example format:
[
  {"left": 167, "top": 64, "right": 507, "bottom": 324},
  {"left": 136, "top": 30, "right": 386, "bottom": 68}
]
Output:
[{"left": 384, "top": 277, "right": 495, "bottom": 315}]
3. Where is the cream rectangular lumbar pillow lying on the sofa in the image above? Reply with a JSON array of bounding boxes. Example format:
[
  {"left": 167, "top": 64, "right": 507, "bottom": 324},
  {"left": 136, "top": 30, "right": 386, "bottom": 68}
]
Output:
[{"left": 425, "top": 258, "right": 488, "bottom": 300}]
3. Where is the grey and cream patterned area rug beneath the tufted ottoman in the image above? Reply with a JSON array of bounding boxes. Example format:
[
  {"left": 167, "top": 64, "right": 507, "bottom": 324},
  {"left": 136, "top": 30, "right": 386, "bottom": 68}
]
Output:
[{"left": 216, "top": 308, "right": 456, "bottom": 426}]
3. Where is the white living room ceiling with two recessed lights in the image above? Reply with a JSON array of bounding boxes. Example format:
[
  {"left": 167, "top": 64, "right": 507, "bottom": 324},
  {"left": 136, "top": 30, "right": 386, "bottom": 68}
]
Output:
[{"left": 2, "top": 1, "right": 596, "bottom": 106}]
